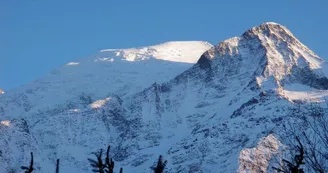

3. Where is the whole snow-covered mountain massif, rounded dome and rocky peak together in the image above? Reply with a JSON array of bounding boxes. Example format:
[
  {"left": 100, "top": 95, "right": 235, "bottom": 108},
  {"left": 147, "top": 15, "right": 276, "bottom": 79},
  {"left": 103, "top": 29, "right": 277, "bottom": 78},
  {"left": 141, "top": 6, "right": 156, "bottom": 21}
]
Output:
[{"left": 0, "top": 23, "right": 328, "bottom": 173}]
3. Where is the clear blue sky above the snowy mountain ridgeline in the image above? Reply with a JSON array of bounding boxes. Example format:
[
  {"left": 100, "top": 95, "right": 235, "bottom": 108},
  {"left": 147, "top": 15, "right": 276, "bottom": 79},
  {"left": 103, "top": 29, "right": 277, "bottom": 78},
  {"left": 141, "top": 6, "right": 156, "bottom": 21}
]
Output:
[{"left": 0, "top": 0, "right": 328, "bottom": 90}]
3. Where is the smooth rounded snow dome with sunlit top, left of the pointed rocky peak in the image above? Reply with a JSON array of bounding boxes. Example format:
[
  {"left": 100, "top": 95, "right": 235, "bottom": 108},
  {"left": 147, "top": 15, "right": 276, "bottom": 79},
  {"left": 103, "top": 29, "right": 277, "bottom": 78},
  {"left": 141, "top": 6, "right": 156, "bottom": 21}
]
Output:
[{"left": 0, "top": 41, "right": 211, "bottom": 120}]
